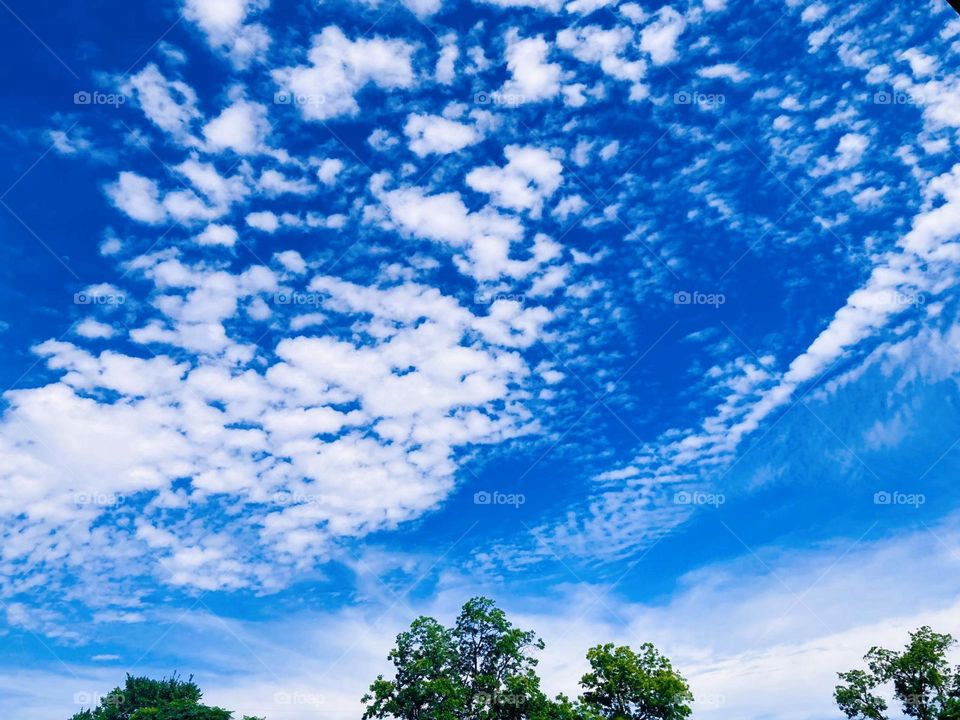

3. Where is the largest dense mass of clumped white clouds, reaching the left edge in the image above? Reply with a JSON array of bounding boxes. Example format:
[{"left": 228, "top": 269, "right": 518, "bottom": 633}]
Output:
[{"left": 0, "top": 248, "right": 551, "bottom": 589}]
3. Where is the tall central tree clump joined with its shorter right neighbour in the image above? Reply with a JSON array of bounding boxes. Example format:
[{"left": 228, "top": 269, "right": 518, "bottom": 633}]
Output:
[{"left": 363, "top": 597, "right": 692, "bottom": 720}]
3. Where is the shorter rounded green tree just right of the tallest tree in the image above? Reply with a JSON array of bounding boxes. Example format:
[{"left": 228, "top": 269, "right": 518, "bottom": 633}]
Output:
[{"left": 580, "top": 643, "right": 693, "bottom": 720}]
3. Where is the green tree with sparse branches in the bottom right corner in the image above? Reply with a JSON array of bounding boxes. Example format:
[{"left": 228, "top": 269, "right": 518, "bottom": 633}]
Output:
[{"left": 834, "top": 626, "right": 960, "bottom": 720}]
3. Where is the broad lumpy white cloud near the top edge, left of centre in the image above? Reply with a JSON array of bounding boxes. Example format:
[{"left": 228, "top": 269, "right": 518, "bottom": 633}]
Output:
[{"left": 273, "top": 25, "right": 415, "bottom": 120}]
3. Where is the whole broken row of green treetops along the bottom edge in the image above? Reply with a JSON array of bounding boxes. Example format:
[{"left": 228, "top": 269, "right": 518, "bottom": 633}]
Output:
[{"left": 70, "top": 597, "right": 960, "bottom": 720}]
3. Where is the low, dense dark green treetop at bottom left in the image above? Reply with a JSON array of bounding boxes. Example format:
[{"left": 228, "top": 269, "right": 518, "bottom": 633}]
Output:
[{"left": 71, "top": 673, "right": 263, "bottom": 720}]
